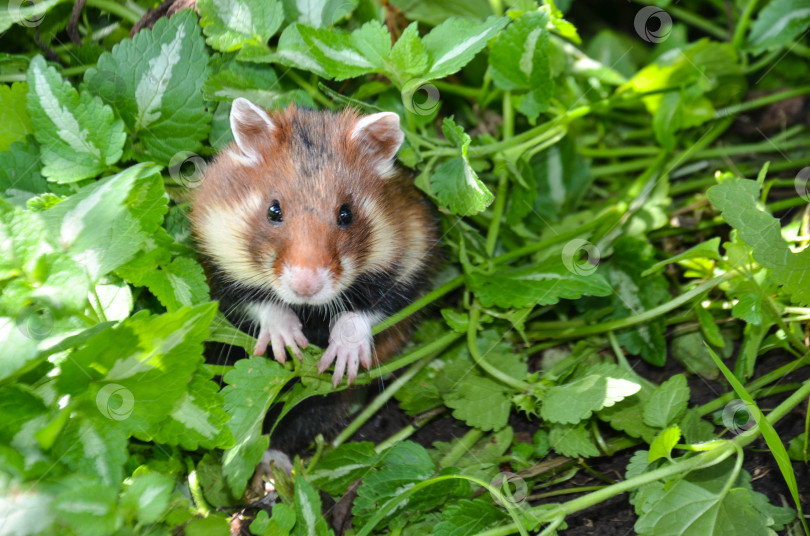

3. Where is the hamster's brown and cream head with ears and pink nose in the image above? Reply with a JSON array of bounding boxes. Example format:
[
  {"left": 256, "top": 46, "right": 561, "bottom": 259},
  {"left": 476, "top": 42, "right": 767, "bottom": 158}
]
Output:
[{"left": 191, "top": 98, "right": 404, "bottom": 306}]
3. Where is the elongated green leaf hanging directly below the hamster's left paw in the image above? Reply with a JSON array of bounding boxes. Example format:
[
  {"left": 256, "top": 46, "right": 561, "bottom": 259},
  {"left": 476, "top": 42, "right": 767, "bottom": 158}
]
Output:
[{"left": 222, "top": 356, "right": 290, "bottom": 497}]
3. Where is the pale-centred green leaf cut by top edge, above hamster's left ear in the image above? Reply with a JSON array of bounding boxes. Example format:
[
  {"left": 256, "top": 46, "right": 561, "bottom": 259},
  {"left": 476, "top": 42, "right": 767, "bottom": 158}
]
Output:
[{"left": 197, "top": 0, "right": 284, "bottom": 52}]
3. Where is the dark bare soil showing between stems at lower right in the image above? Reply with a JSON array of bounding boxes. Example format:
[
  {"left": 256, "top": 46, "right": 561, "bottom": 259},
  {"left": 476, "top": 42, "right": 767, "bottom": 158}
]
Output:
[{"left": 352, "top": 352, "right": 810, "bottom": 536}]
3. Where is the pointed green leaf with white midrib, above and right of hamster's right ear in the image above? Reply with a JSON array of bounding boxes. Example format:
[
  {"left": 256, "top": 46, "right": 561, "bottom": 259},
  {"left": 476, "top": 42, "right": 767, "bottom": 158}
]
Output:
[{"left": 422, "top": 17, "right": 509, "bottom": 80}]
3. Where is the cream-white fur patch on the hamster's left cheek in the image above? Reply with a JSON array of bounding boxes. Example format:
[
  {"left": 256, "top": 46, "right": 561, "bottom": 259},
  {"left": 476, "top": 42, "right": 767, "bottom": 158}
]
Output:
[{"left": 199, "top": 196, "right": 274, "bottom": 288}]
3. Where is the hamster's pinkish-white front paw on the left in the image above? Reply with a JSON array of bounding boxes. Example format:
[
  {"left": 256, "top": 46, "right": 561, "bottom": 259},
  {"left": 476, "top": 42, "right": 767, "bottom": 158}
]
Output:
[{"left": 248, "top": 303, "right": 309, "bottom": 364}]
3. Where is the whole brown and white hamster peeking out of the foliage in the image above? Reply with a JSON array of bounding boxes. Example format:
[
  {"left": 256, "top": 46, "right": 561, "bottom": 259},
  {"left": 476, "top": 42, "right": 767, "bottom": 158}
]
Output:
[{"left": 191, "top": 98, "right": 439, "bottom": 386}]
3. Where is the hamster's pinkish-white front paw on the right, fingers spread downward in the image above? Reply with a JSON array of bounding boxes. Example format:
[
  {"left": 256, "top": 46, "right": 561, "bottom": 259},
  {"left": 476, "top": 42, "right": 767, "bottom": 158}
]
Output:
[{"left": 318, "top": 312, "right": 374, "bottom": 387}]
